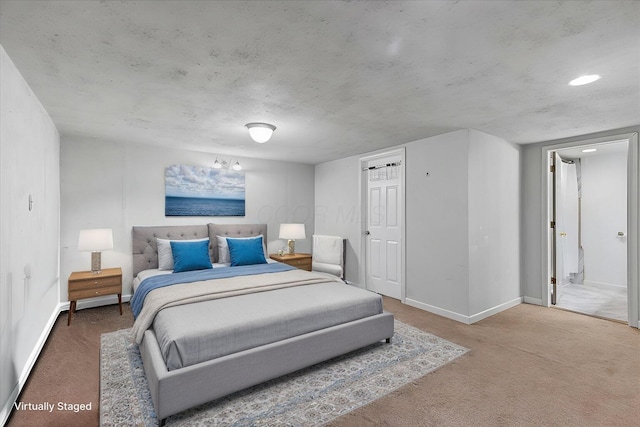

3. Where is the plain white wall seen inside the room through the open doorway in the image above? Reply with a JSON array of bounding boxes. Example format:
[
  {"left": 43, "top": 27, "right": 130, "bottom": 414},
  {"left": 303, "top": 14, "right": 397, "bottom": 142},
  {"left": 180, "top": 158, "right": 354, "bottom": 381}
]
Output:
[{"left": 581, "top": 152, "right": 627, "bottom": 288}]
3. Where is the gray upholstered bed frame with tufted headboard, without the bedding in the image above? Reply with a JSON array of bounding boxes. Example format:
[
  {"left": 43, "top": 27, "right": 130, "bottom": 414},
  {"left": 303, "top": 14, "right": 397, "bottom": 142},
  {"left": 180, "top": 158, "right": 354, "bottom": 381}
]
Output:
[{"left": 133, "top": 224, "right": 394, "bottom": 425}]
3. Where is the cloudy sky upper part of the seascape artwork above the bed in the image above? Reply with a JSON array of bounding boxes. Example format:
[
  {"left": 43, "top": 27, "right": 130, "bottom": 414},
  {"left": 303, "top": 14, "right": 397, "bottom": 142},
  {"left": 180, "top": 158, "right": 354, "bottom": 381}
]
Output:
[{"left": 165, "top": 165, "right": 244, "bottom": 200}]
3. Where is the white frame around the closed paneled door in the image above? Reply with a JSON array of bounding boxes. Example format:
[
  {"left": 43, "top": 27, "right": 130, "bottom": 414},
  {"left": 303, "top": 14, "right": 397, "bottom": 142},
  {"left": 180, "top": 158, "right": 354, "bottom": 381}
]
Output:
[{"left": 359, "top": 147, "right": 407, "bottom": 303}]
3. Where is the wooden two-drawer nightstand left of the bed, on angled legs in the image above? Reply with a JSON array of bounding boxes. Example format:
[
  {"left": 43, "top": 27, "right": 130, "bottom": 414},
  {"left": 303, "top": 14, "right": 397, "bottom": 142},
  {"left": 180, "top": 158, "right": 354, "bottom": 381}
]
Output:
[{"left": 67, "top": 268, "right": 122, "bottom": 326}]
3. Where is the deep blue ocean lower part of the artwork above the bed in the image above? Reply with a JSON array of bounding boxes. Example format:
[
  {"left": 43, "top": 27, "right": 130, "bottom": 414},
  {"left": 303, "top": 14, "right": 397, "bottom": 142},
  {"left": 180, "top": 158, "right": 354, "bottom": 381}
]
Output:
[{"left": 164, "top": 196, "right": 244, "bottom": 216}]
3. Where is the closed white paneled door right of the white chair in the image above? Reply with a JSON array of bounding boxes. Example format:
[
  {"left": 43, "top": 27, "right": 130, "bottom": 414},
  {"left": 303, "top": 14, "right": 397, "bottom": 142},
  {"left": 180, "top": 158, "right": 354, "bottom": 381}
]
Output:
[{"left": 364, "top": 155, "right": 404, "bottom": 299}]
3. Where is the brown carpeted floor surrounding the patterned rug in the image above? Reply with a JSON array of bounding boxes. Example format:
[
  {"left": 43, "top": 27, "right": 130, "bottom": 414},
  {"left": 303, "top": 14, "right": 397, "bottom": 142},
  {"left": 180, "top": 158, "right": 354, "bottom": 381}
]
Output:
[{"left": 8, "top": 298, "right": 640, "bottom": 427}]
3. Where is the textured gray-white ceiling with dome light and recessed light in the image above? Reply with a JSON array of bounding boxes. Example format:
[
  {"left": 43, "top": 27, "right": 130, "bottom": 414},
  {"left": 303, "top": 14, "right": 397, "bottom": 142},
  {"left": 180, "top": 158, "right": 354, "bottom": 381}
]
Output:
[{"left": 0, "top": 0, "right": 640, "bottom": 163}]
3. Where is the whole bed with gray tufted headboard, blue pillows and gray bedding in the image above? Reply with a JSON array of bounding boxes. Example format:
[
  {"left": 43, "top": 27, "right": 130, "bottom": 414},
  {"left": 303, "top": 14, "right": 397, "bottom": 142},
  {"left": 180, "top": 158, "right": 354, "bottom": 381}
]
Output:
[{"left": 131, "top": 224, "right": 393, "bottom": 425}]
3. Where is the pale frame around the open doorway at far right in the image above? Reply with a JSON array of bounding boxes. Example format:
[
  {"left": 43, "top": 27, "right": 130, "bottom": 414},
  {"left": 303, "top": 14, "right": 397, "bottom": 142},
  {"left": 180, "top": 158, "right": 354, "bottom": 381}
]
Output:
[{"left": 541, "top": 132, "right": 640, "bottom": 328}]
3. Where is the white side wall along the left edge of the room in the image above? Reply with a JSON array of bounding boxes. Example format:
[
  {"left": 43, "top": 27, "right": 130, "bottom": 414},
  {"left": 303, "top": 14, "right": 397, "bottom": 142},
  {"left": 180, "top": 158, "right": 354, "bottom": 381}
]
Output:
[{"left": 0, "top": 46, "right": 60, "bottom": 424}]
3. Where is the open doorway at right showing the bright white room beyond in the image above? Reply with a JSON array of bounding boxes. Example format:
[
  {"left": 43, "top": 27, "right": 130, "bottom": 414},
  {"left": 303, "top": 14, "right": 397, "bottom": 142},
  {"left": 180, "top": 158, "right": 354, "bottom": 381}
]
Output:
[{"left": 551, "top": 141, "right": 628, "bottom": 323}]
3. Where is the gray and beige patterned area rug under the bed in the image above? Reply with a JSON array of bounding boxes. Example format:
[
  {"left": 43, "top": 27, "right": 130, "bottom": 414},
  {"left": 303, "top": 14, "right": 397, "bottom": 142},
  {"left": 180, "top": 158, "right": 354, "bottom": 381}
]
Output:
[{"left": 100, "top": 320, "right": 468, "bottom": 427}]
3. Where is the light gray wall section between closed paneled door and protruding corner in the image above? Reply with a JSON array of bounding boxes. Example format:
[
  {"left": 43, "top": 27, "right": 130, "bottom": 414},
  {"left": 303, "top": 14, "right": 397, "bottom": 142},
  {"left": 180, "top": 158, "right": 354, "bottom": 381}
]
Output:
[{"left": 406, "top": 130, "right": 469, "bottom": 316}]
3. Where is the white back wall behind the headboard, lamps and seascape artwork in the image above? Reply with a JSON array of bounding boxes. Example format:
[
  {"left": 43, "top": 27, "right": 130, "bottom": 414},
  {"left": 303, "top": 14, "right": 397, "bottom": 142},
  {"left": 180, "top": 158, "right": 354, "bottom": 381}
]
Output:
[{"left": 60, "top": 137, "right": 314, "bottom": 300}]
